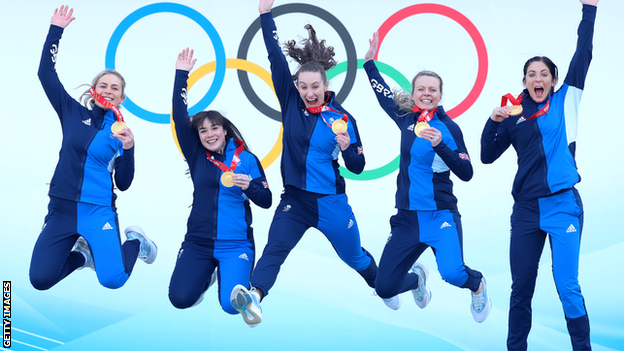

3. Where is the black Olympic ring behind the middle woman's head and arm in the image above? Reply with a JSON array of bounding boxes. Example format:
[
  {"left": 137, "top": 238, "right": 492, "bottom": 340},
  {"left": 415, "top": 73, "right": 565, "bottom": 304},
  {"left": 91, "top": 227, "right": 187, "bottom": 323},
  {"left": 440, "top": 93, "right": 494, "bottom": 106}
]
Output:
[{"left": 237, "top": 4, "right": 357, "bottom": 122}]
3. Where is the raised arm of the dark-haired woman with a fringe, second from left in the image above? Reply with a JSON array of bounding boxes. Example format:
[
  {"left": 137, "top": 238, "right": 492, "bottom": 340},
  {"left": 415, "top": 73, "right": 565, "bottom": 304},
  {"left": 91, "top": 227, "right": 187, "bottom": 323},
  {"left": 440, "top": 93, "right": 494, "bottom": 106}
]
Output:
[{"left": 172, "top": 48, "right": 199, "bottom": 160}]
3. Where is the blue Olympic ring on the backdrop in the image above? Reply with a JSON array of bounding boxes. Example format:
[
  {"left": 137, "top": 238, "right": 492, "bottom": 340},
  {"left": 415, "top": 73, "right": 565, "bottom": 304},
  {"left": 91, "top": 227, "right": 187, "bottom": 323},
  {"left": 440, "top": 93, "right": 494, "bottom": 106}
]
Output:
[{"left": 105, "top": 2, "right": 226, "bottom": 124}]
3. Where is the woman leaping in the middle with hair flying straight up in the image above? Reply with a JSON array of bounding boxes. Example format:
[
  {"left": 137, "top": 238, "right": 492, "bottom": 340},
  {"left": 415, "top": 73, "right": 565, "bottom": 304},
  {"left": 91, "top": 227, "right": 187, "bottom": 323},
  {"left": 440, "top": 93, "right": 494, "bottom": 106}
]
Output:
[{"left": 231, "top": 0, "right": 377, "bottom": 326}]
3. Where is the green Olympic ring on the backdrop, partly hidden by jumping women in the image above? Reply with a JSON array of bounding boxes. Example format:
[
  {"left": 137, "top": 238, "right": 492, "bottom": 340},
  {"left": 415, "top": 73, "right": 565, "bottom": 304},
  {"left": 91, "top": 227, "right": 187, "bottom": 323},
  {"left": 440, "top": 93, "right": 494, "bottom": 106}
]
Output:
[{"left": 327, "top": 59, "right": 412, "bottom": 180}]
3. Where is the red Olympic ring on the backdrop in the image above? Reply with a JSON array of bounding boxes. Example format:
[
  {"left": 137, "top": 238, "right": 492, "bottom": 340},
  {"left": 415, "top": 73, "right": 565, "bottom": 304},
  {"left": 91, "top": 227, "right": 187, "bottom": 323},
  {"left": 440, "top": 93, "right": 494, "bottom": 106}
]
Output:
[{"left": 374, "top": 4, "right": 488, "bottom": 118}]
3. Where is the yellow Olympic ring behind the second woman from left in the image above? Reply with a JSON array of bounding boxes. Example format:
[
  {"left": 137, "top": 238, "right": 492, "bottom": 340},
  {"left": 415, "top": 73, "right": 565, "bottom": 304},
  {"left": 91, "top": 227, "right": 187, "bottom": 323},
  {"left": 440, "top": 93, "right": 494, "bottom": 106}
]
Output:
[{"left": 170, "top": 59, "right": 284, "bottom": 169}]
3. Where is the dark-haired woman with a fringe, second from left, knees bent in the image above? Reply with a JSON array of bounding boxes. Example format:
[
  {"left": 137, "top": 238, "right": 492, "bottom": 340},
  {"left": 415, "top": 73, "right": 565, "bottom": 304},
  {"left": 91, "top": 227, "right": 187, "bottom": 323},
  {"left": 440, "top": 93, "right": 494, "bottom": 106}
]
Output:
[{"left": 169, "top": 48, "right": 272, "bottom": 314}]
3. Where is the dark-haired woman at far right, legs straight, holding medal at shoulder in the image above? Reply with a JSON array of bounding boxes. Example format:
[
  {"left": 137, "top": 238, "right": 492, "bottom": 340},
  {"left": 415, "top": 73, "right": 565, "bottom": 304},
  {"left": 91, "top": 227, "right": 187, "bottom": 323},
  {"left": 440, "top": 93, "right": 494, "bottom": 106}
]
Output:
[{"left": 481, "top": 0, "right": 598, "bottom": 351}]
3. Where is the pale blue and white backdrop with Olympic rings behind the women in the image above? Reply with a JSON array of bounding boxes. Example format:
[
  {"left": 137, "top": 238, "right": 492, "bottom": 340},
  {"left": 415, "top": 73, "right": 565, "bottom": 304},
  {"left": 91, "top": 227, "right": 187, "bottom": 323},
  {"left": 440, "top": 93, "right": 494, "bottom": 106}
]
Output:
[{"left": 0, "top": 0, "right": 624, "bottom": 350}]
